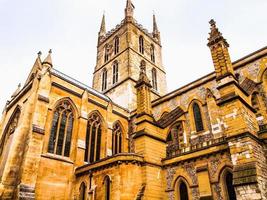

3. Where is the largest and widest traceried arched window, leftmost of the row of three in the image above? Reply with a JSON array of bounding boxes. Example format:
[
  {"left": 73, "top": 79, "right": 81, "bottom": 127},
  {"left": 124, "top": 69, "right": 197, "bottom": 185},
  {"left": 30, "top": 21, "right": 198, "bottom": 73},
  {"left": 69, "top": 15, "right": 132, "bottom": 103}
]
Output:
[{"left": 48, "top": 101, "right": 74, "bottom": 157}]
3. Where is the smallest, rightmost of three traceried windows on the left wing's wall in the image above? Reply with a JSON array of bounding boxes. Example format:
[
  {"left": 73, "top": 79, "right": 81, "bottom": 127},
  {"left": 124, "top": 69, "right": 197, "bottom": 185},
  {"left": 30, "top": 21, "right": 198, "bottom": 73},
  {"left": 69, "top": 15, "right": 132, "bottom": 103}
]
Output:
[{"left": 112, "top": 123, "right": 122, "bottom": 155}]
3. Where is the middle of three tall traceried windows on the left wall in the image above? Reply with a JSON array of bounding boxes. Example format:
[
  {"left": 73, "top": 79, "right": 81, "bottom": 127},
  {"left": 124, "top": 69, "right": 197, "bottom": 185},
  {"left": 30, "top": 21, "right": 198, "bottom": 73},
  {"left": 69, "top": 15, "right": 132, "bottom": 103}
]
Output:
[{"left": 84, "top": 113, "right": 102, "bottom": 163}]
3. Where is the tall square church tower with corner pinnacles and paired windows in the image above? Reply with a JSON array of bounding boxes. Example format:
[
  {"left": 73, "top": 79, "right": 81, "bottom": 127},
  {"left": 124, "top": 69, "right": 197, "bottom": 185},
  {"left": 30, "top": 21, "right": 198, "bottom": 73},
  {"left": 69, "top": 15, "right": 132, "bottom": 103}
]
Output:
[{"left": 93, "top": 0, "right": 167, "bottom": 111}]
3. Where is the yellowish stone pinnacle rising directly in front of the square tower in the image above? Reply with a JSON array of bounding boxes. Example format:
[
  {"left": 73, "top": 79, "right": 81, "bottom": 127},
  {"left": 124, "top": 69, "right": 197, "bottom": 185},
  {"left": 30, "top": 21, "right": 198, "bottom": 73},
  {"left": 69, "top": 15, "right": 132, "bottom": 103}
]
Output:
[{"left": 135, "top": 61, "right": 152, "bottom": 115}]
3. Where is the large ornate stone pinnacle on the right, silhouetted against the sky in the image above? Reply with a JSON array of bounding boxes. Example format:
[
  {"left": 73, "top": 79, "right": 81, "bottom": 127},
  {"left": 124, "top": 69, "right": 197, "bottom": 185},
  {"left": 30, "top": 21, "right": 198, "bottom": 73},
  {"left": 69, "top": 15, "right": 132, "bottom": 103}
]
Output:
[{"left": 207, "top": 19, "right": 234, "bottom": 79}]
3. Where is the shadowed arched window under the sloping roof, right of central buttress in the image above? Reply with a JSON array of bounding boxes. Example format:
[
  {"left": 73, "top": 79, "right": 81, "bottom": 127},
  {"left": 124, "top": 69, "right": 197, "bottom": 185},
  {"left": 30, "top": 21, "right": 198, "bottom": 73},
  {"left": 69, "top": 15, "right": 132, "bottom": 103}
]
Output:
[{"left": 167, "top": 122, "right": 184, "bottom": 157}]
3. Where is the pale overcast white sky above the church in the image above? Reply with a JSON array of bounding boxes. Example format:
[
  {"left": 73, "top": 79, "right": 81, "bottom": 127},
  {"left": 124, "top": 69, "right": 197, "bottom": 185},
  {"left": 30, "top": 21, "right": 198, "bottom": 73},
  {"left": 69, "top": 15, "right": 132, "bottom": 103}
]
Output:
[{"left": 0, "top": 0, "right": 267, "bottom": 110}]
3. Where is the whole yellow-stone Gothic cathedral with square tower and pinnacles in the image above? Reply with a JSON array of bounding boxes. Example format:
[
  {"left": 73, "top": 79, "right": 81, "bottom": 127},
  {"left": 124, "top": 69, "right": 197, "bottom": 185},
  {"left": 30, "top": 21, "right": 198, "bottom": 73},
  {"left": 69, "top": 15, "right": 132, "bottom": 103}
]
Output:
[{"left": 0, "top": 0, "right": 267, "bottom": 200}]
